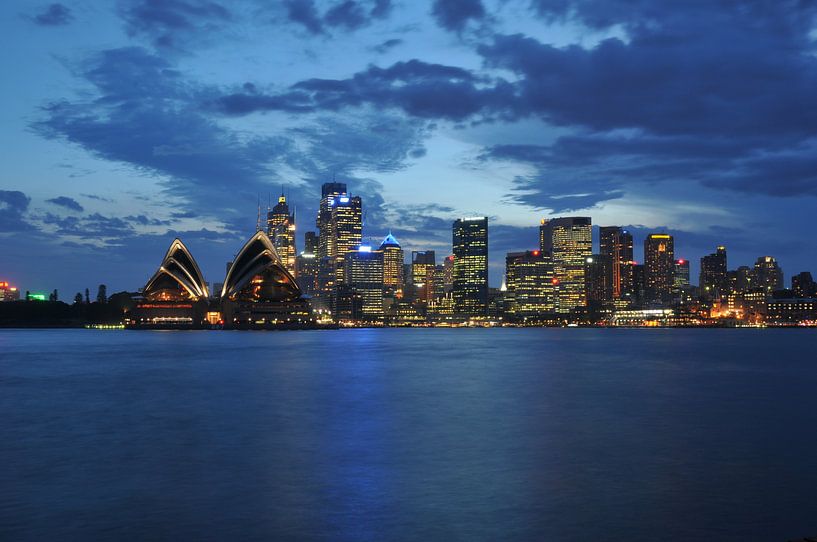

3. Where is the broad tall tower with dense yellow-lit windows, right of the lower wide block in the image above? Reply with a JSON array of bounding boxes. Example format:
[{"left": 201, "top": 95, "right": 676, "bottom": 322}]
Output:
[{"left": 539, "top": 217, "right": 593, "bottom": 313}]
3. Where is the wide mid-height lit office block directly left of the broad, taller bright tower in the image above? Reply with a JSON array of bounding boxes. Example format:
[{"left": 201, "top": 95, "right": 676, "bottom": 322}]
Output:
[{"left": 505, "top": 250, "right": 556, "bottom": 321}]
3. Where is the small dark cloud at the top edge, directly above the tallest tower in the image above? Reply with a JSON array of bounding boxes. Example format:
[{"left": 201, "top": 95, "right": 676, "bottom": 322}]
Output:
[{"left": 284, "top": 0, "right": 392, "bottom": 34}]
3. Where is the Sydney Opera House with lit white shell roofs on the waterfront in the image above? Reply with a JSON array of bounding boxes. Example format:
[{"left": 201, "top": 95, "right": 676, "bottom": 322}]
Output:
[{"left": 126, "top": 231, "right": 314, "bottom": 329}]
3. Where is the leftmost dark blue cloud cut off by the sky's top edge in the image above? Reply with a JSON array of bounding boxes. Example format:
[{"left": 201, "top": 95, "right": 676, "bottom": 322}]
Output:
[{"left": 120, "top": 0, "right": 232, "bottom": 49}]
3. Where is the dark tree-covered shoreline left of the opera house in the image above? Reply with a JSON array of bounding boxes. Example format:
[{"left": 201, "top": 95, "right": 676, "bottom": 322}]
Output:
[{"left": 0, "top": 292, "right": 134, "bottom": 327}]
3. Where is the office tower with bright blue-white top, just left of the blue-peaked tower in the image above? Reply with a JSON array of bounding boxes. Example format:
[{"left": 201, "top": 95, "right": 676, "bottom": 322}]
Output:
[{"left": 343, "top": 245, "right": 383, "bottom": 320}]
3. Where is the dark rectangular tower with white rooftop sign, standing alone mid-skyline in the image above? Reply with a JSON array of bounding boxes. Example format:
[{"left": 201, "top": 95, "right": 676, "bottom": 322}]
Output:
[{"left": 452, "top": 217, "right": 488, "bottom": 316}]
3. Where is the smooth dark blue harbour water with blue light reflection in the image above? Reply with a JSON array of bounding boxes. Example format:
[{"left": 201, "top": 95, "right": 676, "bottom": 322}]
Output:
[{"left": 0, "top": 329, "right": 817, "bottom": 541}]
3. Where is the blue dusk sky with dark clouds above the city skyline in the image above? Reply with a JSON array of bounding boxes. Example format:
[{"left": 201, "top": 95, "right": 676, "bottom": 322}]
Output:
[{"left": 0, "top": 0, "right": 817, "bottom": 299}]
